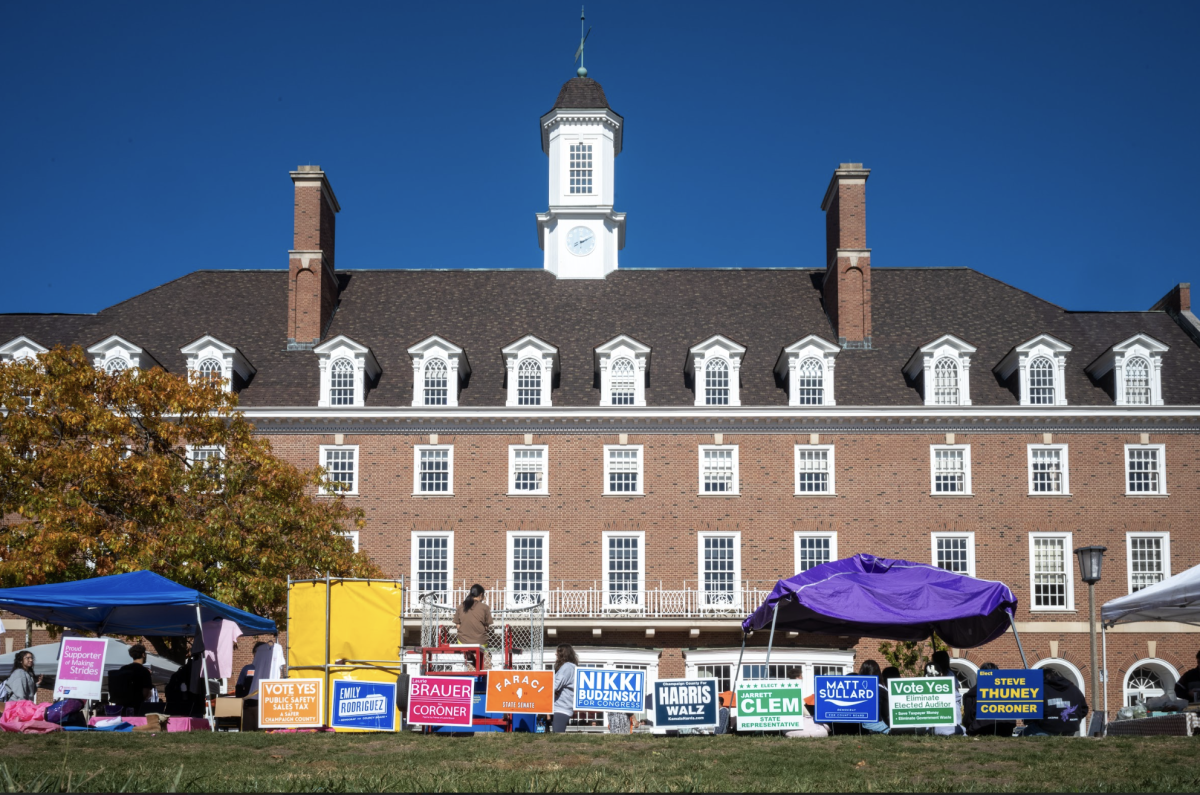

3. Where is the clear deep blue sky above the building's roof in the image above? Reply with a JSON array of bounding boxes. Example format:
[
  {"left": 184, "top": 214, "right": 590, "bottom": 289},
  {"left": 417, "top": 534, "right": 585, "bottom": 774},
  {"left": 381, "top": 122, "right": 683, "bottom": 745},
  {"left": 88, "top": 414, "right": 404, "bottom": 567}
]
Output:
[{"left": 0, "top": 0, "right": 1200, "bottom": 312}]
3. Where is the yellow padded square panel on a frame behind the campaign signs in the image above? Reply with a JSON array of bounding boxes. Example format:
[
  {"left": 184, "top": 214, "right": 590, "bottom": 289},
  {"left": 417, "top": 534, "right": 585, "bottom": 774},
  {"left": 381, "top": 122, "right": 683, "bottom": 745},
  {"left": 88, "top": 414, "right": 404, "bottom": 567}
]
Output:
[{"left": 288, "top": 578, "right": 404, "bottom": 731}]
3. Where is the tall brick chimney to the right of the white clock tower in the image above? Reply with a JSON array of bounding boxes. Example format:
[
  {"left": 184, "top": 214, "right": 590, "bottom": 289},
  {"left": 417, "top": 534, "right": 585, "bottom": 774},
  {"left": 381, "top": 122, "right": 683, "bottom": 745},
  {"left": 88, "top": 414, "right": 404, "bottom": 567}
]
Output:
[{"left": 821, "top": 163, "right": 871, "bottom": 348}]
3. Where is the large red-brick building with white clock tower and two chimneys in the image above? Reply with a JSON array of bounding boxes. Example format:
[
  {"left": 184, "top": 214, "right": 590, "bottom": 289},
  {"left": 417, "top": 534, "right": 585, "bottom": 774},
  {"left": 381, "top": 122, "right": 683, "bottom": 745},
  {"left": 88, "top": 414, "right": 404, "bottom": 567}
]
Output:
[{"left": 0, "top": 77, "right": 1200, "bottom": 710}]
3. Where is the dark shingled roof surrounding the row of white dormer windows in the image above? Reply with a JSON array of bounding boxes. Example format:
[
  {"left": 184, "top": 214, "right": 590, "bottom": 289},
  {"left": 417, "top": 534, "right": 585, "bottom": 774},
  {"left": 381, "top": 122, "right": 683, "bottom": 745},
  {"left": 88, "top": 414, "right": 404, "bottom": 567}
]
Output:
[{"left": 0, "top": 268, "right": 1200, "bottom": 406}]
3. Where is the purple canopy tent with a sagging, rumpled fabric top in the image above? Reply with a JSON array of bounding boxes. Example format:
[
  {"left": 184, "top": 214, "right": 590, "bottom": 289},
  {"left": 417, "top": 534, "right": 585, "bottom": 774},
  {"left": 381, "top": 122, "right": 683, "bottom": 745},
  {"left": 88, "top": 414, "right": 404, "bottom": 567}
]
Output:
[{"left": 738, "top": 555, "right": 1027, "bottom": 691}]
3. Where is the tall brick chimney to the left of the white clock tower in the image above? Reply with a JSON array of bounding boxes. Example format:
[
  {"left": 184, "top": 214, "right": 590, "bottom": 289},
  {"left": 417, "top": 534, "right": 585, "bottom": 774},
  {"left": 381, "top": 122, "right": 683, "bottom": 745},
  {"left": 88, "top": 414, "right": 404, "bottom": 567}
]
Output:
[{"left": 288, "top": 166, "right": 342, "bottom": 351}]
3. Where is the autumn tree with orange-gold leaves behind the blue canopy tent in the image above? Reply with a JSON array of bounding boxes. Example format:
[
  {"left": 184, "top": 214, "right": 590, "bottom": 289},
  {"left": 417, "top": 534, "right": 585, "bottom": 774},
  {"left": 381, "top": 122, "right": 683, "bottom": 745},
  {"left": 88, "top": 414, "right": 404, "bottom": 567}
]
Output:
[{"left": 0, "top": 347, "right": 380, "bottom": 652}]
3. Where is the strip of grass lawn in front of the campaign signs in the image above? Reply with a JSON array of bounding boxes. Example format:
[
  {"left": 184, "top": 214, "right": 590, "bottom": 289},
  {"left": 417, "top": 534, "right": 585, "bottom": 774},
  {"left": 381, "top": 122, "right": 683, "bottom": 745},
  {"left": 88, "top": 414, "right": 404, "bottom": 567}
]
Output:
[{"left": 0, "top": 733, "right": 1200, "bottom": 793}]
